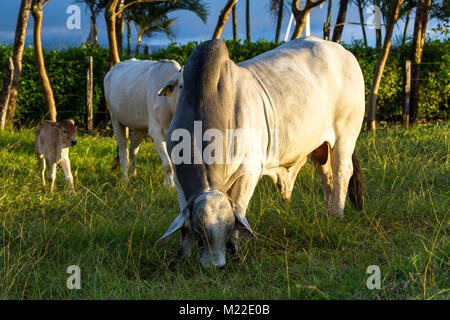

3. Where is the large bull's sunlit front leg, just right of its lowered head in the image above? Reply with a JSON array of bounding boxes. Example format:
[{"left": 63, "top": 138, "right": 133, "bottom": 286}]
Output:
[{"left": 227, "top": 173, "right": 259, "bottom": 255}]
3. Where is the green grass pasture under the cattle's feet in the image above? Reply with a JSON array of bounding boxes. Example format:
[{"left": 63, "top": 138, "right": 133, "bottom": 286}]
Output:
[{"left": 0, "top": 123, "right": 450, "bottom": 299}]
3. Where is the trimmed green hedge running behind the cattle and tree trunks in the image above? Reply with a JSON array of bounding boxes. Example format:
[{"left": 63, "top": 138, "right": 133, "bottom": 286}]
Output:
[{"left": 0, "top": 40, "right": 450, "bottom": 125}]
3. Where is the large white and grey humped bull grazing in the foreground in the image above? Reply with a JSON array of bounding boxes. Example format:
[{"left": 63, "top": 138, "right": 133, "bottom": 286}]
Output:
[{"left": 157, "top": 37, "right": 365, "bottom": 268}]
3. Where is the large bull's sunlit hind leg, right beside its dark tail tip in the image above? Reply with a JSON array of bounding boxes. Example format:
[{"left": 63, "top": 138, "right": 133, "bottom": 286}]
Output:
[{"left": 328, "top": 140, "right": 355, "bottom": 218}]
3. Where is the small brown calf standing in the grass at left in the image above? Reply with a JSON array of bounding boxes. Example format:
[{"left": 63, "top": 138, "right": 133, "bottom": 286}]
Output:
[{"left": 34, "top": 120, "right": 77, "bottom": 194}]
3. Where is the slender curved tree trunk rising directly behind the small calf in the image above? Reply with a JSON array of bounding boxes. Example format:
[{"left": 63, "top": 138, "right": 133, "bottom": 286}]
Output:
[{"left": 31, "top": 0, "right": 56, "bottom": 121}]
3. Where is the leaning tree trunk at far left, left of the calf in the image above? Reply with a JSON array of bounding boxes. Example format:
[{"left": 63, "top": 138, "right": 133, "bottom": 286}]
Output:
[{"left": 5, "top": 0, "right": 31, "bottom": 126}]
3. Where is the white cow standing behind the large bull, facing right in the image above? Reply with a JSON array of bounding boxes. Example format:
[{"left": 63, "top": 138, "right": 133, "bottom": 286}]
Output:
[{"left": 103, "top": 59, "right": 183, "bottom": 186}]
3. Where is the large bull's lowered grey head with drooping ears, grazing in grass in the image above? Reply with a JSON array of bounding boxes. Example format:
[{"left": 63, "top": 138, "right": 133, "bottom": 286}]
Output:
[{"left": 156, "top": 190, "right": 256, "bottom": 268}]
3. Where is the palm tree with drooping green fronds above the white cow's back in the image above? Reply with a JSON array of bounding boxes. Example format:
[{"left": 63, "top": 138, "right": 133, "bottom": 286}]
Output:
[{"left": 125, "top": 0, "right": 208, "bottom": 55}]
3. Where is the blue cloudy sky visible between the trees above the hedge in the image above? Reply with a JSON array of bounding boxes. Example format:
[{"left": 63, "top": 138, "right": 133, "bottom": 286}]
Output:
[{"left": 0, "top": 0, "right": 435, "bottom": 49}]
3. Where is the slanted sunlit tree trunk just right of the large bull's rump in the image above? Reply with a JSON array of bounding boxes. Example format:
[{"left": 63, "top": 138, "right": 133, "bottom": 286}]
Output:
[{"left": 367, "top": 0, "right": 404, "bottom": 131}]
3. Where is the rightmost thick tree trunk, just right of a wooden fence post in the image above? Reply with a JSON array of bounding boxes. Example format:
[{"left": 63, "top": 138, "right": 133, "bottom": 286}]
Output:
[{"left": 409, "top": 0, "right": 432, "bottom": 124}]
